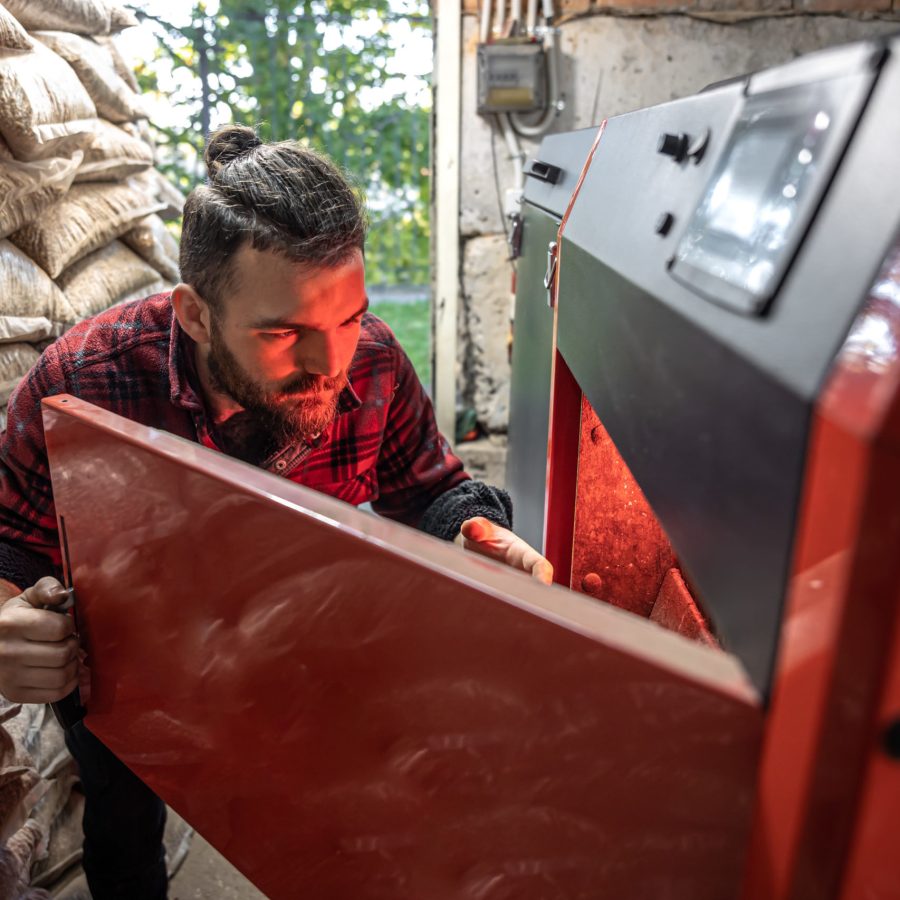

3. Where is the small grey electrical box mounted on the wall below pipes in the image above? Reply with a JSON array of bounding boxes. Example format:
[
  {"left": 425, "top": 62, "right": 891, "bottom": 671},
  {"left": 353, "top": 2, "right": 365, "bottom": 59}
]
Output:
[{"left": 478, "top": 41, "right": 547, "bottom": 115}]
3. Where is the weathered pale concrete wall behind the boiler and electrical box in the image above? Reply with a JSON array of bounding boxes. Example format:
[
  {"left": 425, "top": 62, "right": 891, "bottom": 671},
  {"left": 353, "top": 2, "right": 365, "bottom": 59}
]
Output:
[{"left": 454, "top": 0, "right": 900, "bottom": 460}]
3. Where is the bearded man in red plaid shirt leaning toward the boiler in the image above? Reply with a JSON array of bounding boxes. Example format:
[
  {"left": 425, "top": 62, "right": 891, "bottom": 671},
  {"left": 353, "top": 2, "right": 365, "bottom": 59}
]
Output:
[{"left": 0, "top": 126, "right": 552, "bottom": 900}]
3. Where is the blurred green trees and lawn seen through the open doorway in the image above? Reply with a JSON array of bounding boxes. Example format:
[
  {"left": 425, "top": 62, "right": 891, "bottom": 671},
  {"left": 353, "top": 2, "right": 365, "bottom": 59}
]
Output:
[{"left": 119, "top": 0, "right": 433, "bottom": 387}]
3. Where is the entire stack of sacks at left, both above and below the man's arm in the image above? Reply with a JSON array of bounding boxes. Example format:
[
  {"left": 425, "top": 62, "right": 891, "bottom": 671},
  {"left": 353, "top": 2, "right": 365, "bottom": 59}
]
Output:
[{"left": 0, "top": 0, "right": 186, "bottom": 900}]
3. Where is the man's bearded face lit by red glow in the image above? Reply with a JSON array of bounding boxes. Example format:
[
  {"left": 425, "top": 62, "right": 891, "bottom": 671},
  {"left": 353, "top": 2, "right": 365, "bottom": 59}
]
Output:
[{"left": 207, "top": 246, "right": 368, "bottom": 439}]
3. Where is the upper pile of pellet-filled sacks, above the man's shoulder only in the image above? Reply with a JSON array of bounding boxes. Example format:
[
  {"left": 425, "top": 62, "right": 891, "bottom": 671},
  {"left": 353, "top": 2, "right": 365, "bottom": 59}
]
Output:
[{"left": 0, "top": 0, "right": 184, "bottom": 436}]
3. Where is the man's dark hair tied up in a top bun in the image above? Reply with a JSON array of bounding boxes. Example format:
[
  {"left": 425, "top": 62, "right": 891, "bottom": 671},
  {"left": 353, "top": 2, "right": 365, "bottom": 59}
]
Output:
[{"left": 179, "top": 125, "right": 368, "bottom": 309}]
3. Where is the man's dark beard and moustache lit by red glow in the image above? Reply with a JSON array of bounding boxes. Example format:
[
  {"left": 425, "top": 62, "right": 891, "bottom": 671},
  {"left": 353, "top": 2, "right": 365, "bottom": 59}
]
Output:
[{"left": 207, "top": 317, "right": 347, "bottom": 448}]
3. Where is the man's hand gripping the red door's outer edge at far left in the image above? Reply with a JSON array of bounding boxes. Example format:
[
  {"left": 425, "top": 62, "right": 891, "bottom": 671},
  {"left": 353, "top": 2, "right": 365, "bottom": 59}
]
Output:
[{"left": 0, "top": 578, "right": 78, "bottom": 703}]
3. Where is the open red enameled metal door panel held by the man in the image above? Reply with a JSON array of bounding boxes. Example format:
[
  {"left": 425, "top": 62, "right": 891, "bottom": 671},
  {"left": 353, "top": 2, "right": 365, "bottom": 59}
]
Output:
[{"left": 45, "top": 397, "right": 761, "bottom": 900}]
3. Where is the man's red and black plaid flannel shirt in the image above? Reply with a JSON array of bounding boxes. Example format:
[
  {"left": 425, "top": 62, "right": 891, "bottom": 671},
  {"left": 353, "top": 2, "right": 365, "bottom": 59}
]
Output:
[{"left": 0, "top": 294, "right": 469, "bottom": 586}]
